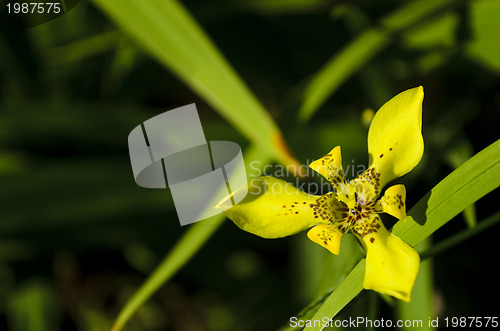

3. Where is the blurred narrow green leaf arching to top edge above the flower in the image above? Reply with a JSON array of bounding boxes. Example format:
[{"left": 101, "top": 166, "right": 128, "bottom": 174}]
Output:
[{"left": 299, "top": 0, "right": 460, "bottom": 121}]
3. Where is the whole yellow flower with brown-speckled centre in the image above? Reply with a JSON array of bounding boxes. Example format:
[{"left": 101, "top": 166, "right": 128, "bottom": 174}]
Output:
[{"left": 219, "top": 87, "right": 424, "bottom": 301}]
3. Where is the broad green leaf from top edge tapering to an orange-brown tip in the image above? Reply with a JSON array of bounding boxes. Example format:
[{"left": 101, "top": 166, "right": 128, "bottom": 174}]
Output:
[{"left": 93, "top": 0, "right": 297, "bottom": 164}]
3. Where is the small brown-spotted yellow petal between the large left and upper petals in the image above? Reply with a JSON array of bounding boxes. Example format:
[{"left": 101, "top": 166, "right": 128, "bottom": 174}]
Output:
[{"left": 309, "top": 146, "right": 356, "bottom": 209}]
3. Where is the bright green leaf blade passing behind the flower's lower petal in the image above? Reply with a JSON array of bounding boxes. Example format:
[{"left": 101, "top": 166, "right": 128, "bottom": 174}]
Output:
[{"left": 304, "top": 140, "right": 500, "bottom": 331}]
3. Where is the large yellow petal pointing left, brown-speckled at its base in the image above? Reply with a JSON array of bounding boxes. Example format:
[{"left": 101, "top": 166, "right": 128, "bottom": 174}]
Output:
[{"left": 218, "top": 177, "right": 341, "bottom": 238}]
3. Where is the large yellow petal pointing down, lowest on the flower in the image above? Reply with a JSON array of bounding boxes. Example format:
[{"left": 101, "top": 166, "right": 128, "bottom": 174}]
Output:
[{"left": 355, "top": 214, "right": 420, "bottom": 302}]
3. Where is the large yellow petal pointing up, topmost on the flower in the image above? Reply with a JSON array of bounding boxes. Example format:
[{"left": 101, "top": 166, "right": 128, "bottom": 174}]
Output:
[{"left": 368, "top": 86, "right": 424, "bottom": 187}]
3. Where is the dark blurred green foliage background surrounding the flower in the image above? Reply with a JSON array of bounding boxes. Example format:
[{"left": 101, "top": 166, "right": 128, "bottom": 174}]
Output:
[{"left": 0, "top": 0, "right": 500, "bottom": 331}]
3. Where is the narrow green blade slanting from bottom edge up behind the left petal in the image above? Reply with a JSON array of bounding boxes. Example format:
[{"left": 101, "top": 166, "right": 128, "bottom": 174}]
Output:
[{"left": 112, "top": 148, "right": 270, "bottom": 331}]
